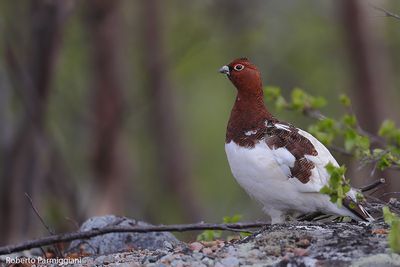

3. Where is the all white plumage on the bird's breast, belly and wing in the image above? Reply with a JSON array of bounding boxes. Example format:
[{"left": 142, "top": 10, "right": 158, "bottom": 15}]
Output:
[{"left": 225, "top": 125, "right": 359, "bottom": 223}]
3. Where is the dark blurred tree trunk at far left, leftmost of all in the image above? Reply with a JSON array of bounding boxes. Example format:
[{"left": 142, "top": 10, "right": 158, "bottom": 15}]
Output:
[{"left": 0, "top": 0, "right": 67, "bottom": 245}]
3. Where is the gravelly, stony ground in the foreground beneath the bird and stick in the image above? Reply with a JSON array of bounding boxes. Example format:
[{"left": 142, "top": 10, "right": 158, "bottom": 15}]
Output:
[{"left": 39, "top": 222, "right": 400, "bottom": 267}]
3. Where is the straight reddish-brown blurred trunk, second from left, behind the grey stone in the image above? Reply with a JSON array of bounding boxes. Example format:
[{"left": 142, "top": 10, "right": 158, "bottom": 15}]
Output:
[{"left": 86, "top": 0, "right": 129, "bottom": 214}]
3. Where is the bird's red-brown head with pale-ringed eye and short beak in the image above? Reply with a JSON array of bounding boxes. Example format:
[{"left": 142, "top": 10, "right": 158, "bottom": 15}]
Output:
[{"left": 219, "top": 58, "right": 262, "bottom": 93}]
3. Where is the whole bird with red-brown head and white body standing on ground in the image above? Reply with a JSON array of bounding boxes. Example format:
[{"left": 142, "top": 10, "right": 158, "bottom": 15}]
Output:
[{"left": 219, "top": 58, "right": 374, "bottom": 224}]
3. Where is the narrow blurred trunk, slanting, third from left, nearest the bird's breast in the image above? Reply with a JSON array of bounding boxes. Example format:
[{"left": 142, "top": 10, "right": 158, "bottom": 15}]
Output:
[{"left": 142, "top": 0, "right": 200, "bottom": 221}]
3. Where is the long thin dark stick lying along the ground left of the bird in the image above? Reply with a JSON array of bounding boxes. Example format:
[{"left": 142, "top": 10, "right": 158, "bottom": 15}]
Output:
[{"left": 0, "top": 222, "right": 267, "bottom": 255}]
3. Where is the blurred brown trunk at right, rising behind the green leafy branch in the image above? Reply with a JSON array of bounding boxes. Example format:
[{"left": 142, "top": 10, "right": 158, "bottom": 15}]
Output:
[{"left": 341, "top": 0, "right": 399, "bottom": 193}]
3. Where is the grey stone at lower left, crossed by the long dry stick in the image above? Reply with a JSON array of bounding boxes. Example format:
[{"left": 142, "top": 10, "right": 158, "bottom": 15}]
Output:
[{"left": 70, "top": 215, "right": 180, "bottom": 255}]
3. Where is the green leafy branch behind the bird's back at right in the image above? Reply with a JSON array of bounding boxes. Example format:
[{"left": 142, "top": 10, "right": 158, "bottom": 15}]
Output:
[{"left": 264, "top": 87, "right": 400, "bottom": 173}]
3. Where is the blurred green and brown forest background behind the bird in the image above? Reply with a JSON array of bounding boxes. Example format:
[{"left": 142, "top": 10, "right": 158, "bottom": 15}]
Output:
[{"left": 0, "top": 0, "right": 400, "bottom": 244}]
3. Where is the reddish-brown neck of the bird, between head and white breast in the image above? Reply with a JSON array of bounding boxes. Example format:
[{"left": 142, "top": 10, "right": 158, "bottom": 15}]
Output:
[{"left": 225, "top": 89, "right": 273, "bottom": 146}]
